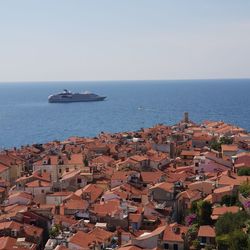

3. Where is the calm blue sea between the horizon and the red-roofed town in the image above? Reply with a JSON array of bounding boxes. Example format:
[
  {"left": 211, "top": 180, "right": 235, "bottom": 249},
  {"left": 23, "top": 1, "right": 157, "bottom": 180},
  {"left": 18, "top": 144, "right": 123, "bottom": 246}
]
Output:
[{"left": 0, "top": 79, "right": 250, "bottom": 148}]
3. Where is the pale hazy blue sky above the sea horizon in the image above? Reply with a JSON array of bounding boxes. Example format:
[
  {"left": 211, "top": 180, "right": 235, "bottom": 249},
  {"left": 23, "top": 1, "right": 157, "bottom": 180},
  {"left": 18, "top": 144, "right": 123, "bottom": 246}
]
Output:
[{"left": 0, "top": 0, "right": 250, "bottom": 82}]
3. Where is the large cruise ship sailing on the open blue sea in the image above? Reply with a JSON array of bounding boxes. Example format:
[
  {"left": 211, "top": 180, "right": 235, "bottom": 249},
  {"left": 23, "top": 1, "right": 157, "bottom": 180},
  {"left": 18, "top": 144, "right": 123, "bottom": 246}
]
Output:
[{"left": 48, "top": 89, "right": 106, "bottom": 103}]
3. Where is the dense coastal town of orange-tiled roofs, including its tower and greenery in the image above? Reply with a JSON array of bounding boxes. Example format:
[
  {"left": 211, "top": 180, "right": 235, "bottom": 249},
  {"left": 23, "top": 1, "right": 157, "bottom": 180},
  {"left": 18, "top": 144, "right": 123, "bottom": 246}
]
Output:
[{"left": 0, "top": 112, "right": 250, "bottom": 250}]
